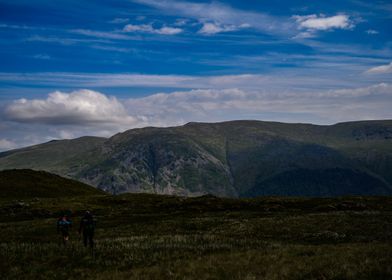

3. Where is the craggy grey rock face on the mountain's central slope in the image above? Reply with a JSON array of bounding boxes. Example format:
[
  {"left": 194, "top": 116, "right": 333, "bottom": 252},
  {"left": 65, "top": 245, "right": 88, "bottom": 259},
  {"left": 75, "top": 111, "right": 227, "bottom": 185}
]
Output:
[{"left": 77, "top": 129, "right": 236, "bottom": 196}]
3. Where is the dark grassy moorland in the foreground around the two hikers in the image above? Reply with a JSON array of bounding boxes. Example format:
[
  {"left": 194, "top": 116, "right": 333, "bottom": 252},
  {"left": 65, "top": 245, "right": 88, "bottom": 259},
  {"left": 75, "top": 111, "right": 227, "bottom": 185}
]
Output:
[{"left": 0, "top": 171, "right": 392, "bottom": 279}]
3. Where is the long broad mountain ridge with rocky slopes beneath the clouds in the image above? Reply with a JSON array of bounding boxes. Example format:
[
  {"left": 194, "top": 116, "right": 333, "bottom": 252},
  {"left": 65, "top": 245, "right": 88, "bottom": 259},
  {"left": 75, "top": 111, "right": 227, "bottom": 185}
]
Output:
[{"left": 0, "top": 120, "right": 392, "bottom": 197}]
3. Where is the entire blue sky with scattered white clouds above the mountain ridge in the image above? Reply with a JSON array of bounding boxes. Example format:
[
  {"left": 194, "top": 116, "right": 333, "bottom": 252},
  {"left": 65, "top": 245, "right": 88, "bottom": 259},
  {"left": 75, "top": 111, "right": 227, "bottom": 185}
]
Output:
[{"left": 0, "top": 0, "right": 392, "bottom": 151}]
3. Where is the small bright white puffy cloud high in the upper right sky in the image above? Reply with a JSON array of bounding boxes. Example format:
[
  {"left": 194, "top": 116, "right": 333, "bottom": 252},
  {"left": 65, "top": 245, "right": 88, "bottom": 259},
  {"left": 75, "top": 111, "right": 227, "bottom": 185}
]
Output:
[{"left": 293, "top": 14, "right": 354, "bottom": 30}]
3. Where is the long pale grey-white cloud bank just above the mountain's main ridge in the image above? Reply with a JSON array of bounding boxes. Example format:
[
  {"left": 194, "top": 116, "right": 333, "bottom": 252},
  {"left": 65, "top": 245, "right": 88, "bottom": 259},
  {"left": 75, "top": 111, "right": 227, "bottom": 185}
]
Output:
[{"left": 125, "top": 83, "right": 392, "bottom": 125}]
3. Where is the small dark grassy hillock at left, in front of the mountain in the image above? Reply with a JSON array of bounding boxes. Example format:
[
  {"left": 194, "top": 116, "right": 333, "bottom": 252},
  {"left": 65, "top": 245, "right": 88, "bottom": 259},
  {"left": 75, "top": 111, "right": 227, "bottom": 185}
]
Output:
[{"left": 0, "top": 169, "right": 104, "bottom": 200}]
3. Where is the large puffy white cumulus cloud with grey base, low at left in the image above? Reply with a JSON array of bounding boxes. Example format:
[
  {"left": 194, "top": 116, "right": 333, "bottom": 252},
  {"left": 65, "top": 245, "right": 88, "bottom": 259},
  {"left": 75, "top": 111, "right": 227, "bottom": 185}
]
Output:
[{"left": 5, "top": 90, "right": 137, "bottom": 125}]
